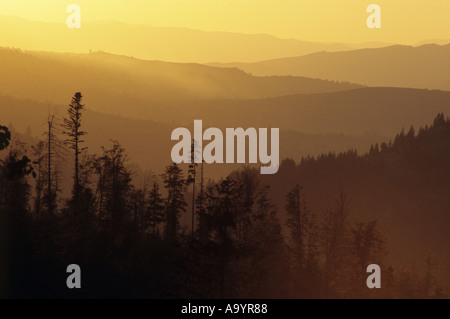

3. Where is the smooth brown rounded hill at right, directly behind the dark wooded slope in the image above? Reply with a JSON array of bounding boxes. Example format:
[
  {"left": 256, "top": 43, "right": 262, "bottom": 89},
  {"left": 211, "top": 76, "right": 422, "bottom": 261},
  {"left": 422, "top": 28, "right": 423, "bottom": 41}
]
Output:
[{"left": 170, "top": 87, "right": 450, "bottom": 138}]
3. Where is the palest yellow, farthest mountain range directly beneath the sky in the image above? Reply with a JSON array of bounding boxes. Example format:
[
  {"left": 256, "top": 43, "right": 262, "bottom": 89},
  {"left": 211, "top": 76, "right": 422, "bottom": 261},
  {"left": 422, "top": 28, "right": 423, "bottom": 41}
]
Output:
[{"left": 0, "top": 16, "right": 387, "bottom": 63}]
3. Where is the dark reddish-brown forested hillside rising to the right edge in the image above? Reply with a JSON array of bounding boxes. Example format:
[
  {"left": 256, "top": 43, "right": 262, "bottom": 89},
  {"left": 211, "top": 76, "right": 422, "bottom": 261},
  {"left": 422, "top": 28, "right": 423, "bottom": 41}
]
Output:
[{"left": 267, "top": 114, "right": 450, "bottom": 275}]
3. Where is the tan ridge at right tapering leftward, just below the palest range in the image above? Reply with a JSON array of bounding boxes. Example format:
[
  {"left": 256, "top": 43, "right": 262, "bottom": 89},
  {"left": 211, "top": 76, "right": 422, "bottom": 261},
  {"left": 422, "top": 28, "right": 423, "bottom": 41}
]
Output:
[{"left": 210, "top": 44, "right": 450, "bottom": 90}]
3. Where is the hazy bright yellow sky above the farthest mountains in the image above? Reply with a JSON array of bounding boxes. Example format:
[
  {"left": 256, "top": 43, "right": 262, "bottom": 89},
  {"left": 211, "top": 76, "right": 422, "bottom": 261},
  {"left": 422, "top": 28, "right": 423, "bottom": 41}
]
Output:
[{"left": 0, "top": 0, "right": 450, "bottom": 44}]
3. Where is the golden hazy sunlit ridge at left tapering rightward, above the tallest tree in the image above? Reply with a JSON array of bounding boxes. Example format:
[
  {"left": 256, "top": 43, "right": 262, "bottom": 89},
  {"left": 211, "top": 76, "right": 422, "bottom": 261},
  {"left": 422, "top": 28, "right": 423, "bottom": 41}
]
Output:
[{"left": 0, "top": 48, "right": 361, "bottom": 118}]
